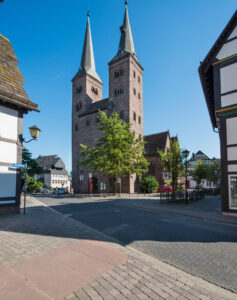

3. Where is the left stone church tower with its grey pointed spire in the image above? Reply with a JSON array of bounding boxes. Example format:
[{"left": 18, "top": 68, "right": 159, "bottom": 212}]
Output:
[{"left": 72, "top": 13, "right": 103, "bottom": 192}]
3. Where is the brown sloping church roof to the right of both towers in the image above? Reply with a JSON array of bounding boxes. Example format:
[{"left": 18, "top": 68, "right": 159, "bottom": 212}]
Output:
[{"left": 144, "top": 131, "right": 170, "bottom": 155}]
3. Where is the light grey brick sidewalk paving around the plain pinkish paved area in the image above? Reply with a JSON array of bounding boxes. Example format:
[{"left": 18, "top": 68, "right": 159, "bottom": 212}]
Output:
[{"left": 0, "top": 199, "right": 237, "bottom": 300}]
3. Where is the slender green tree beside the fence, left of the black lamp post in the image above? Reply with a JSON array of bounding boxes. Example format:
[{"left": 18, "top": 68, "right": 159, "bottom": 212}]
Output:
[{"left": 158, "top": 141, "right": 184, "bottom": 191}]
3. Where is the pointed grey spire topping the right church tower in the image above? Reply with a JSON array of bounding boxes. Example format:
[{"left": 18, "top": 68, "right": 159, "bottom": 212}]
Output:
[{"left": 113, "top": 1, "right": 137, "bottom": 60}]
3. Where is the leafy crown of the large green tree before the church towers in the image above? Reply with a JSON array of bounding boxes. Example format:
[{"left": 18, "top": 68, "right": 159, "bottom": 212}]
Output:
[{"left": 79, "top": 112, "right": 149, "bottom": 190}]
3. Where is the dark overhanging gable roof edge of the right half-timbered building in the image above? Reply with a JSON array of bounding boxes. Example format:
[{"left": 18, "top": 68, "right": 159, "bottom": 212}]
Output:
[{"left": 198, "top": 10, "right": 237, "bottom": 128}]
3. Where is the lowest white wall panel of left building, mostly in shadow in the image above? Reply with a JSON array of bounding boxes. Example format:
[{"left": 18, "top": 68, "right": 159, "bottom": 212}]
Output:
[{"left": 0, "top": 166, "right": 16, "bottom": 198}]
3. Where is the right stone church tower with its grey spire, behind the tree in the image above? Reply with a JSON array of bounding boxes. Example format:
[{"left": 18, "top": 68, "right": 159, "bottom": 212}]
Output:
[{"left": 109, "top": 1, "right": 143, "bottom": 193}]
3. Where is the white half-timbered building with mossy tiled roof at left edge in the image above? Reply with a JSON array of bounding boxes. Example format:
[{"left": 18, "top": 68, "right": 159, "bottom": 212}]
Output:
[{"left": 0, "top": 34, "right": 38, "bottom": 214}]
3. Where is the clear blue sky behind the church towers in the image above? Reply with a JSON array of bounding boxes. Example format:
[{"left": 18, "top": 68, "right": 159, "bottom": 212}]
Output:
[{"left": 0, "top": 0, "right": 237, "bottom": 171}]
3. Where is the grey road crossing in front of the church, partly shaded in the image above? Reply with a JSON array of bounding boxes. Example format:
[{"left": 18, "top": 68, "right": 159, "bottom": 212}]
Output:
[{"left": 35, "top": 197, "right": 237, "bottom": 293}]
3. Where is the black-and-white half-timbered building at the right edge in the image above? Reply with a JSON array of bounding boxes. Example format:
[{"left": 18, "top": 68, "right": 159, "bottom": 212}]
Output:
[{"left": 199, "top": 11, "right": 237, "bottom": 212}]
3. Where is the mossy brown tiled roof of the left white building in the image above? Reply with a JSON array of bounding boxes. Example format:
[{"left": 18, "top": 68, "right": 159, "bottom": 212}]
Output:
[{"left": 0, "top": 34, "right": 39, "bottom": 111}]
